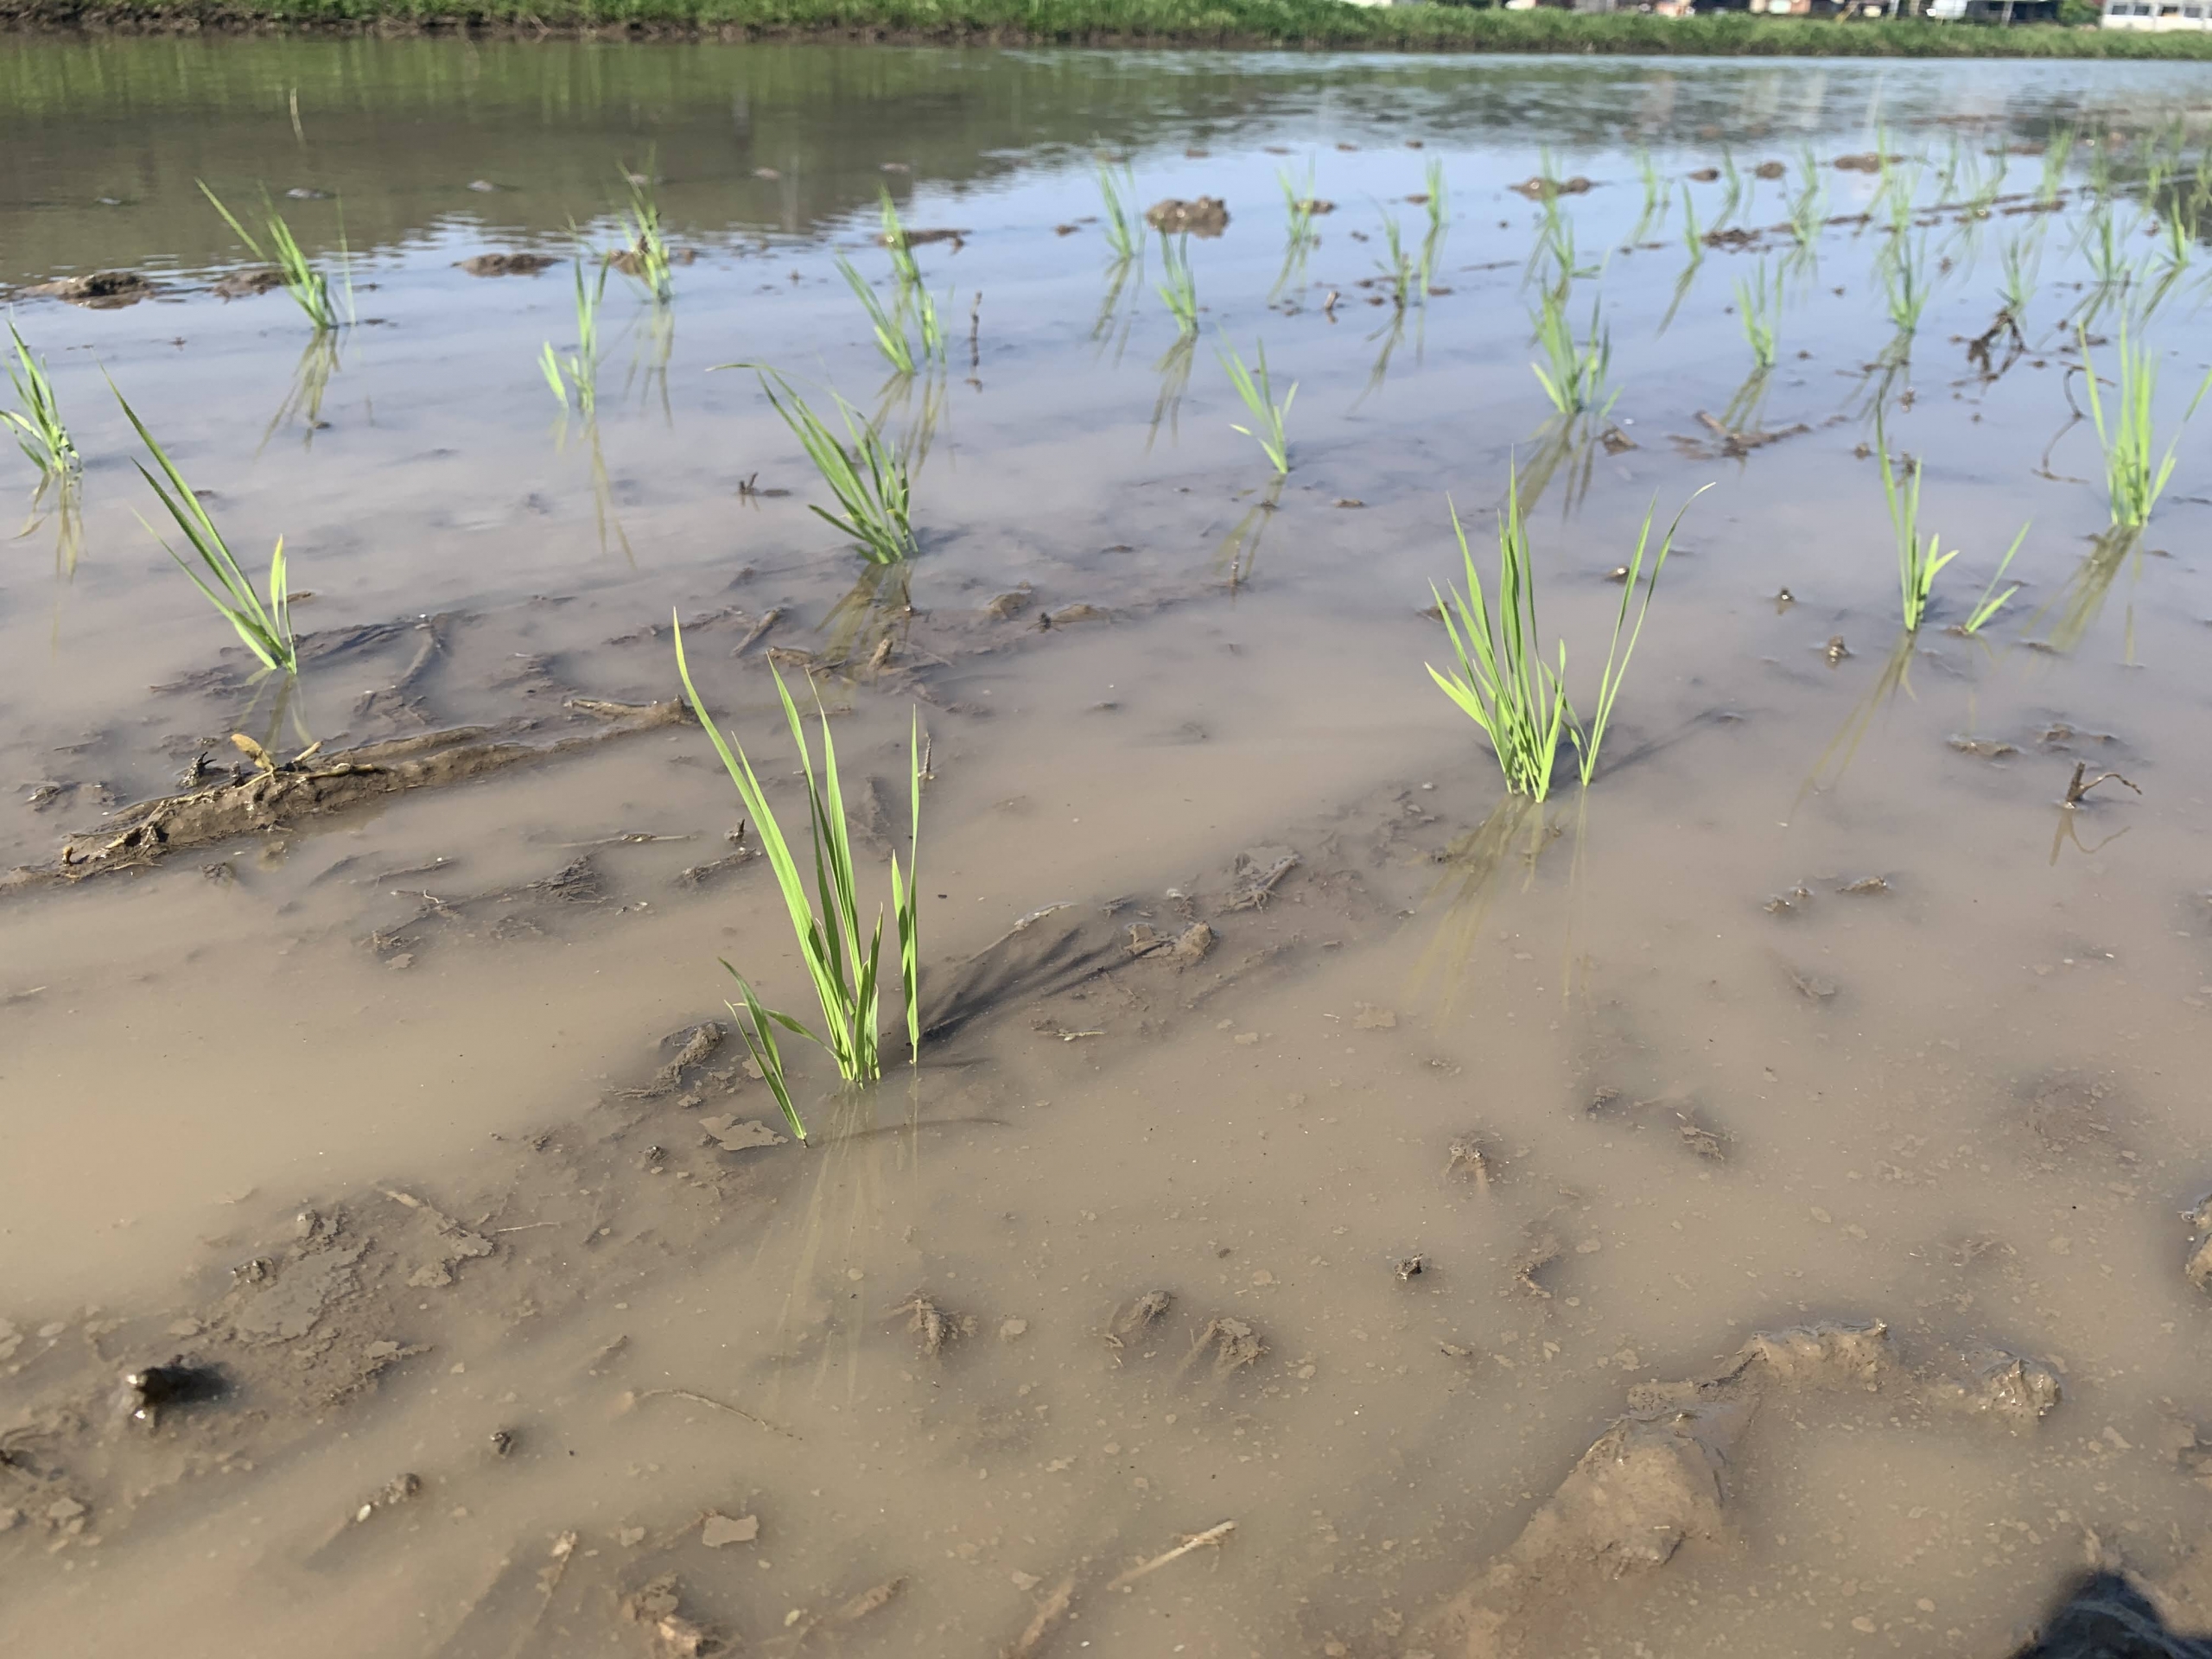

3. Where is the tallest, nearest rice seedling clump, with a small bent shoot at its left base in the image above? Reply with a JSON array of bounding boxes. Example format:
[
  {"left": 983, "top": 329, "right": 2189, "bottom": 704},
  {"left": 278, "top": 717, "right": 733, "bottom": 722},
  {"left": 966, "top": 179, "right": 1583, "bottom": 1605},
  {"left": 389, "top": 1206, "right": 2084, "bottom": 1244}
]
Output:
[{"left": 677, "top": 621, "right": 923, "bottom": 1141}]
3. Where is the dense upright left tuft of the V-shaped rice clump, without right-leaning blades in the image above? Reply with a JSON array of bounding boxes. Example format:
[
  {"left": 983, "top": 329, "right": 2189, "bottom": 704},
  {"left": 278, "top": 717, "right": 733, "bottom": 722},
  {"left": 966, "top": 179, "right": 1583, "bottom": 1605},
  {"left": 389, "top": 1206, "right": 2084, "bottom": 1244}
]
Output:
[{"left": 1425, "top": 480, "right": 1571, "bottom": 801}]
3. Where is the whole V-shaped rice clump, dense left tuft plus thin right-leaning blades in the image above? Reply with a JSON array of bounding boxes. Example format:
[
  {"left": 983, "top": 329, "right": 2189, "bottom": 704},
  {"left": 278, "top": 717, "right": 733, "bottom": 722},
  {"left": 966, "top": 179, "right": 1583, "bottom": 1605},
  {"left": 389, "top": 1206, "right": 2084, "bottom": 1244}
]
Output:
[{"left": 1427, "top": 478, "right": 1712, "bottom": 801}]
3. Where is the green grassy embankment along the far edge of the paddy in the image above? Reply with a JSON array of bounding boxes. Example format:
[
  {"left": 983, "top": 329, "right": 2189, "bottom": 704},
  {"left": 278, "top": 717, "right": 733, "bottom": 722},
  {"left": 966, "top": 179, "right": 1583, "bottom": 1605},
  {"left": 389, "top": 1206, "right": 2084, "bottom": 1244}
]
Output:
[{"left": 13, "top": 0, "right": 2212, "bottom": 60}]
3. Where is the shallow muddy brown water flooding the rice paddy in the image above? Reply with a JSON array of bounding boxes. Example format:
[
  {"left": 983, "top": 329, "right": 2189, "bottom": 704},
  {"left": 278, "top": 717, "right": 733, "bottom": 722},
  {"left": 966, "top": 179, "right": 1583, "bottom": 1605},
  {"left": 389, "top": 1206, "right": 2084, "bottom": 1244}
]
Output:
[{"left": 0, "top": 40, "right": 2212, "bottom": 1659}]
